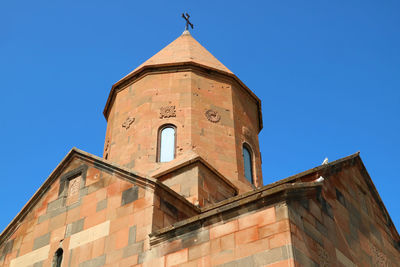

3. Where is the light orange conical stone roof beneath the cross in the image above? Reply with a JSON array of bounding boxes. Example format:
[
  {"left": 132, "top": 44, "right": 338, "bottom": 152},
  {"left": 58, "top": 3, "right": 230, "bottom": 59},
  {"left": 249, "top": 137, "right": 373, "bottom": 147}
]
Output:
[{"left": 128, "top": 31, "right": 233, "bottom": 76}]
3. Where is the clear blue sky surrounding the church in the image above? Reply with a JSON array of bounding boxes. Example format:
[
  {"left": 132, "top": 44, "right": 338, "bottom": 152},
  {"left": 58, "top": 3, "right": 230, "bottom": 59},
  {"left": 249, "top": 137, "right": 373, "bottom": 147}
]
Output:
[{"left": 0, "top": 0, "right": 400, "bottom": 231}]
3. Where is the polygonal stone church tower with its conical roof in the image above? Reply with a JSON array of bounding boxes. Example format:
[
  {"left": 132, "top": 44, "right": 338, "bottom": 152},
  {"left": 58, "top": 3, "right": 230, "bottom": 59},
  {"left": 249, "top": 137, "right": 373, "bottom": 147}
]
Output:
[{"left": 104, "top": 31, "right": 262, "bottom": 198}]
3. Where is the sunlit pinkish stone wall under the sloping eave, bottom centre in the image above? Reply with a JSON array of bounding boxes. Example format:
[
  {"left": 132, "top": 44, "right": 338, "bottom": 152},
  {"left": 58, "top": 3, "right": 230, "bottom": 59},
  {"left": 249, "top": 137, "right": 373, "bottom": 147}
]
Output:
[{"left": 144, "top": 203, "right": 294, "bottom": 267}]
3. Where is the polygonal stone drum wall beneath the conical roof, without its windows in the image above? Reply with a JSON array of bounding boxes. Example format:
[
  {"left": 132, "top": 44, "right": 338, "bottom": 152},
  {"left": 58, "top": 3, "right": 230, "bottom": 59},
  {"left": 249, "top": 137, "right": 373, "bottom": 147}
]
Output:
[{"left": 104, "top": 69, "right": 262, "bottom": 195}]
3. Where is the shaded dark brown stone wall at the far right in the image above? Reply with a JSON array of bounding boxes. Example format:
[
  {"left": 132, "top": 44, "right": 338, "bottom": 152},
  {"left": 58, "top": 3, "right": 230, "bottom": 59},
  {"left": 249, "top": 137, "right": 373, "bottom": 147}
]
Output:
[{"left": 289, "top": 162, "right": 400, "bottom": 266}]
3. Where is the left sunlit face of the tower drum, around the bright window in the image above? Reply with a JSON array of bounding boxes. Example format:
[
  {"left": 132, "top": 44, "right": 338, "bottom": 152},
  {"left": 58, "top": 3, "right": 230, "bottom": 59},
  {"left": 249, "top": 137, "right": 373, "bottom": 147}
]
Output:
[{"left": 106, "top": 72, "right": 191, "bottom": 174}]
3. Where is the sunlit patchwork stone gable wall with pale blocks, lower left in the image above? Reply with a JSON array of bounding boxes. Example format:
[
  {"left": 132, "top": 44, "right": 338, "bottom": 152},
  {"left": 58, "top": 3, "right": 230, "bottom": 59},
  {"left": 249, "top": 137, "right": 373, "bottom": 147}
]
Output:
[{"left": 0, "top": 159, "right": 194, "bottom": 267}]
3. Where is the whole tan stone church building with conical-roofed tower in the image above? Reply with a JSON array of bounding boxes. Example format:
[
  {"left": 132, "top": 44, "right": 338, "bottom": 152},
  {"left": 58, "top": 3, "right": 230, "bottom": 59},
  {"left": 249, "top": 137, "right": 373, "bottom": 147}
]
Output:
[{"left": 0, "top": 25, "right": 400, "bottom": 267}]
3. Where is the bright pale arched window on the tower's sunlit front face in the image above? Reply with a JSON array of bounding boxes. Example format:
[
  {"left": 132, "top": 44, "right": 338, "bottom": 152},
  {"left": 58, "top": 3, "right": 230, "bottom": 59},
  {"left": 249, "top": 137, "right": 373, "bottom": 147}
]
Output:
[{"left": 158, "top": 125, "right": 176, "bottom": 162}]
